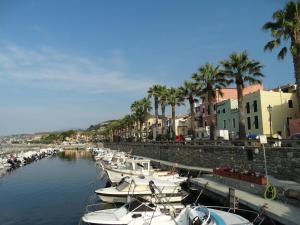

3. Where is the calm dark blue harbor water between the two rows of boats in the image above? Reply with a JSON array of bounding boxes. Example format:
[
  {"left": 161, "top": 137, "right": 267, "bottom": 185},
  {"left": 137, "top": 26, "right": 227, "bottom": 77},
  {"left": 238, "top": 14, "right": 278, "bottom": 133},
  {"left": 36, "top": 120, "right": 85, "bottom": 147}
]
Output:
[{"left": 0, "top": 151, "right": 106, "bottom": 225}]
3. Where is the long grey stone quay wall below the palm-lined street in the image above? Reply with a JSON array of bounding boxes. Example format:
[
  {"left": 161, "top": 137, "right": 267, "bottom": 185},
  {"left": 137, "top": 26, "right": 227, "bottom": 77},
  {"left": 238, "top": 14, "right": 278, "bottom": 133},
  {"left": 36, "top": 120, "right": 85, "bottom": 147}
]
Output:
[{"left": 104, "top": 143, "right": 300, "bottom": 182}]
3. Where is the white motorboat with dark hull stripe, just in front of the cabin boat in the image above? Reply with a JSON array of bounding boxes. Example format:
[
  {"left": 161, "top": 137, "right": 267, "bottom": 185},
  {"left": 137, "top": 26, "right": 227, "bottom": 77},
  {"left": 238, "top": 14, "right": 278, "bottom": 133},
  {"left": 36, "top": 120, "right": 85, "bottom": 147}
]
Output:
[{"left": 95, "top": 177, "right": 187, "bottom": 203}]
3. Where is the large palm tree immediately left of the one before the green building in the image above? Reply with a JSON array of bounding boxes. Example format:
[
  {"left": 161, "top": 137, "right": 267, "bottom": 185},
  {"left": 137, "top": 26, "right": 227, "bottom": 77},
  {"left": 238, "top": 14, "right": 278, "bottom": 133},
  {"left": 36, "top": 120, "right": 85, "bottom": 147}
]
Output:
[{"left": 192, "top": 63, "right": 226, "bottom": 140}]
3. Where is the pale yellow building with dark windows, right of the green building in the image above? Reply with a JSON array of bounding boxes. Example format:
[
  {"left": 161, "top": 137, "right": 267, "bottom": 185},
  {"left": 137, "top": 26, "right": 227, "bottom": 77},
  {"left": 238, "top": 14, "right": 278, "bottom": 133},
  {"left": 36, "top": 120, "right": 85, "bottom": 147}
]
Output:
[{"left": 244, "top": 90, "right": 299, "bottom": 138}]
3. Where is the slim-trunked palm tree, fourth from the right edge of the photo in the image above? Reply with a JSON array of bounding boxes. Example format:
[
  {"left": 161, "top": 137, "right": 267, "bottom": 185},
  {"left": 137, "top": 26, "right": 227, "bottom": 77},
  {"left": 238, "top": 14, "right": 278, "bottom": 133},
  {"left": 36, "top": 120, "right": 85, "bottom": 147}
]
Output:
[{"left": 179, "top": 81, "right": 200, "bottom": 140}]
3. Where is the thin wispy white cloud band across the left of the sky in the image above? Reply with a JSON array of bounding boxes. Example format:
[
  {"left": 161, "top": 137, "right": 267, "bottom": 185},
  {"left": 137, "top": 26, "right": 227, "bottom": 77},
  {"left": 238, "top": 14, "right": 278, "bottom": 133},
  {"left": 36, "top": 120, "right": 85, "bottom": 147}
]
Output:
[{"left": 0, "top": 42, "right": 154, "bottom": 93}]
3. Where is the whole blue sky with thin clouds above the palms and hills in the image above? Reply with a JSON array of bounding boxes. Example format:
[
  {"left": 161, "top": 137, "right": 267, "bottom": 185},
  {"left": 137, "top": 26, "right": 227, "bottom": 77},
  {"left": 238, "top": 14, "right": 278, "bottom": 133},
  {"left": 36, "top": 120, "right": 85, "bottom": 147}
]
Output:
[{"left": 0, "top": 0, "right": 294, "bottom": 135}]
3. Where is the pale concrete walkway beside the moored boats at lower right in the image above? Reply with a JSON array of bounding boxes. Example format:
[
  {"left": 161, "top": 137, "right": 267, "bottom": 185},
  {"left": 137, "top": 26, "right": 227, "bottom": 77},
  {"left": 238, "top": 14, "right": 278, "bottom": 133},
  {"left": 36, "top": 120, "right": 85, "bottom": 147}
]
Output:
[{"left": 191, "top": 178, "right": 300, "bottom": 225}]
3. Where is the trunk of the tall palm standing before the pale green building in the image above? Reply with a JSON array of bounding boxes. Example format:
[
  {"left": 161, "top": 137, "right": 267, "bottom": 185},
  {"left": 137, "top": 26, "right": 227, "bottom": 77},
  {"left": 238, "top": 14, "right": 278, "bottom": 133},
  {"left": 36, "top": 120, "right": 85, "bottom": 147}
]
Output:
[{"left": 236, "top": 81, "right": 246, "bottom": 139}]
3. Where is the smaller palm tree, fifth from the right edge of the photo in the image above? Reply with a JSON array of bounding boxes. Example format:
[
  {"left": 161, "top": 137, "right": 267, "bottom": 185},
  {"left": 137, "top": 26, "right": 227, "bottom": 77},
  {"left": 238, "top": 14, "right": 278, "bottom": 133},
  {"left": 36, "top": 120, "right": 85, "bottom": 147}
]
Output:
[{"left": 167, "top": 87, "right": 184, "bottom": 140}]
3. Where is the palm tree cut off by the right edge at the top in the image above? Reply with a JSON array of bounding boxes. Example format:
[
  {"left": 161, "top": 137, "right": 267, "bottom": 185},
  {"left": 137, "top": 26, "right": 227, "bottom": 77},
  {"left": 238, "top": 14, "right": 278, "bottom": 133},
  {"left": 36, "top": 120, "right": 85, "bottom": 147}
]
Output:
[{"left": 263, "top": 1, "right": 300, "bottom": 110}]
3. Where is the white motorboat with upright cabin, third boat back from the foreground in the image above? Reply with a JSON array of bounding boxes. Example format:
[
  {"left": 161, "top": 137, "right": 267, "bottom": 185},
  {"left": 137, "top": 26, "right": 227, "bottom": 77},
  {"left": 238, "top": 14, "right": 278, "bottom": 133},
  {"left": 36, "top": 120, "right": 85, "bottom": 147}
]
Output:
[{"left": 102, "top": 159, "right": 187, "bottom": 184}]
